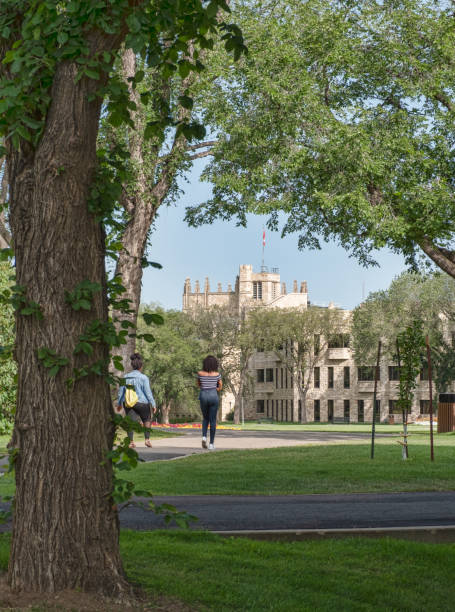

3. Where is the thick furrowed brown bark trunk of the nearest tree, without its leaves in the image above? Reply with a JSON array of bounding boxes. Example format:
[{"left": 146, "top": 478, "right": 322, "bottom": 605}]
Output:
[{"left": 8, "top": 63, "right": 127, "bottom": 595}]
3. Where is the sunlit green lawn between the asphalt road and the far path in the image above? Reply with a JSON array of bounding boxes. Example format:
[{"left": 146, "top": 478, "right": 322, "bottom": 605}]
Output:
[{"left": 0, "top": 433, "right": 455, "bottom": 495}]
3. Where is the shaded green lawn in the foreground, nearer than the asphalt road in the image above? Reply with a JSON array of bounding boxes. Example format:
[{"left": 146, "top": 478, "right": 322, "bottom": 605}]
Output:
[{"left": 0, "top": 531, "right": 455, "bottom": 612}]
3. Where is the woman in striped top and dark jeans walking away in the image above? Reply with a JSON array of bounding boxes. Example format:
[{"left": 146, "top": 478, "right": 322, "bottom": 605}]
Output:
[{"left": 197, "top": 355, "right": 223, "bottom": 450}]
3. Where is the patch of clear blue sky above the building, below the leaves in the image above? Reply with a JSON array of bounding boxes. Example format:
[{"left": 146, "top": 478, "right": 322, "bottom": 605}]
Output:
[{"left": 142, "top": 163, "right": 405, "bottom": 309}]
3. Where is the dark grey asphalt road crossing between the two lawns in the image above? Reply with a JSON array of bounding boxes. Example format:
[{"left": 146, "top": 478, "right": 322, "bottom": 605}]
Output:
[{"left": 120, "top": 491, "right": 455, "bottom": 531}]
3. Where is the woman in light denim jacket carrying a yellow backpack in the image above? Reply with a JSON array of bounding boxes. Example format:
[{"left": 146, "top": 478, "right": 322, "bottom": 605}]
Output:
[{"left": 117, "top": 353, "right": 156, "bottom": 448}]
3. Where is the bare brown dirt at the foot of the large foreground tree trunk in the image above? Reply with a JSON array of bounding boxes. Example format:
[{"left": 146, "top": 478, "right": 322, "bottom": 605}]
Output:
[{"left": 0, "top": 576, "right": 198, "bottom": 612}]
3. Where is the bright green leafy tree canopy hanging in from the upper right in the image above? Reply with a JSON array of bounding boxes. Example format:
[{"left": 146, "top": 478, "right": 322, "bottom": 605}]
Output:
[{"left": 188, "top": 0, "right": 455, "bottom": 277}]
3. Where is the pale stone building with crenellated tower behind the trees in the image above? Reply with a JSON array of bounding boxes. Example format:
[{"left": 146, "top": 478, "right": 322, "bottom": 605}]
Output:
[{"left": 183, "top": 265, "right": 442, "bottom": 423}]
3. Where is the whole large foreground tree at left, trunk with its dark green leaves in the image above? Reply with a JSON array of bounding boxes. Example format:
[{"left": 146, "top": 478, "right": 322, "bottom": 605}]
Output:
[{"left": 0, "top": 0, "right": 246, "bottom": 595}]
